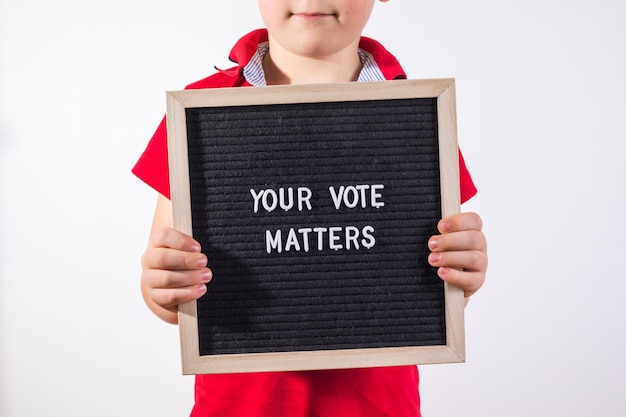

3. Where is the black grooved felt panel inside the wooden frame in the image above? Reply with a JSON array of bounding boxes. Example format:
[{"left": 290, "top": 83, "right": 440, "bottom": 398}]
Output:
[{"left": 186, "top": 98, "right": 446, "bottom": 355}]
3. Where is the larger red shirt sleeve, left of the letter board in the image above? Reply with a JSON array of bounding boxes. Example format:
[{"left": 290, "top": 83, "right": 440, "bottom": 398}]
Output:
[{"left": 132, "top": 117, "right": 170, "bottom": 198}]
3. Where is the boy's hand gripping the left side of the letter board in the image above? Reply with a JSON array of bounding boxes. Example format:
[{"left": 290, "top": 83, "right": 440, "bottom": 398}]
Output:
[{"left": 141, "top": 227, "right": 212, "bottom": 324}]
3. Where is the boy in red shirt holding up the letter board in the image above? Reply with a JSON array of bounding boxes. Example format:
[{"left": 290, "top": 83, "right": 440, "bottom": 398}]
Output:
[{"left": 133, "top": 0, "right": 487, "bottom": 417}]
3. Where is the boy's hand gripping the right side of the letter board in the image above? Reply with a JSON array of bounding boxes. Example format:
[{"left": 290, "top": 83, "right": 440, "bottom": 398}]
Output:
[{"left": 428, "top": 213, "right": 487, "bottom": 302}]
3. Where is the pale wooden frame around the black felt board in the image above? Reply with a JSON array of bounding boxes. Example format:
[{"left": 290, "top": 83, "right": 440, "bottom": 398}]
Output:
[{"left": 167, "top": 79, "right": 465, "bottom": 374}]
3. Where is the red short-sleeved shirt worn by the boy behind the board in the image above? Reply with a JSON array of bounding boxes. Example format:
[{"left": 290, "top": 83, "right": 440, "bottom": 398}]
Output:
[{"left": 133, "top": 30, "right": 476, "bottom": 417}]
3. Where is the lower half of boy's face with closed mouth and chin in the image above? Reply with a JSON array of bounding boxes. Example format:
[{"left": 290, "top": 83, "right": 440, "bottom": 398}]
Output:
[{"left": 258, "top": 0, "right": 387, "bottom": 58}]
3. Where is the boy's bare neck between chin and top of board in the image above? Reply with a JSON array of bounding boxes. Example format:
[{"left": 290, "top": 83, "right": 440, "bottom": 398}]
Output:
[{"left": 263, "top": 42, "right": 362, "bottom": 85}]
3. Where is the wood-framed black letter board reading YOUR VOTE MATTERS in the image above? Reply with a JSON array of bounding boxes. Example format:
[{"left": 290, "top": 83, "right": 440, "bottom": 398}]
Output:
[{"left": 167, "top": 79, "right": 465, "bottom": 374}]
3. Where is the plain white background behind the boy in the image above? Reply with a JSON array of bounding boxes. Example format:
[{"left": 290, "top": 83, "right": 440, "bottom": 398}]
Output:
[{"left": 0, "top": 0, "right": 626, "bottom": 417}]
